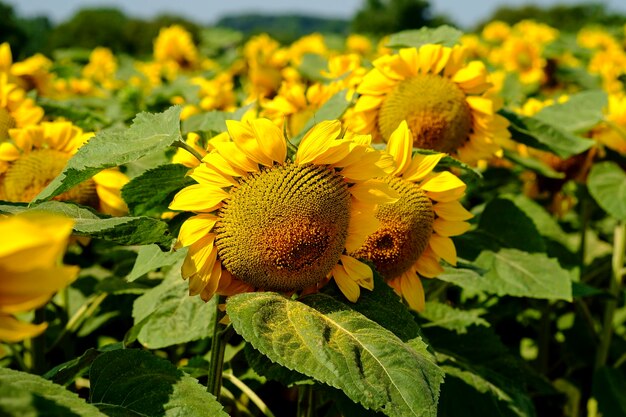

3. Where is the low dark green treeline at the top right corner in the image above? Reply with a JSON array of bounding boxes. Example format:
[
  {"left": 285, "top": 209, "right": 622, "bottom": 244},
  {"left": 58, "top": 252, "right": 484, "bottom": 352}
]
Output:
[{"left": 476, "top": 3, "right": 626, "bottom": 32}]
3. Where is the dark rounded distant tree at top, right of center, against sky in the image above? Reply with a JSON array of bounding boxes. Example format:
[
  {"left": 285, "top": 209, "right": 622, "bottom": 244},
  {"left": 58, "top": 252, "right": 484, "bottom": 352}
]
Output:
[{"left": 352, "top": 0, "right": 449, "bottom": 35}]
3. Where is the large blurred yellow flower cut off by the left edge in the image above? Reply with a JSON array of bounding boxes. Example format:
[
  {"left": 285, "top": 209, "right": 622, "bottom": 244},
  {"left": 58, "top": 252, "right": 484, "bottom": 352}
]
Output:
[{"left": 0, "top": 213, "right": 78, "bottom": 343}]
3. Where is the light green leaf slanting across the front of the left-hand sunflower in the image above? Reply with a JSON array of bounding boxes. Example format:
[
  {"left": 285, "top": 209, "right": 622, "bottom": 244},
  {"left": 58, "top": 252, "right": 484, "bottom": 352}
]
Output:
[{"left": 35, "top": 106, "right": 182, "bottom": 201}]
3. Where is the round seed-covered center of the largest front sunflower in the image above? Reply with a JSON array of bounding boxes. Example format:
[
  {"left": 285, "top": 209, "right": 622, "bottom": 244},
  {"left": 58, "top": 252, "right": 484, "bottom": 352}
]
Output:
[{"left": 215, "top": 161, "right": 350, "bottom": 291}]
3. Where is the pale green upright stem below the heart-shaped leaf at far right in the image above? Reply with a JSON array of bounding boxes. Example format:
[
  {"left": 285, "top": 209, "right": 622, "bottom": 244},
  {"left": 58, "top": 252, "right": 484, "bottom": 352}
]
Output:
[{"left": 595, "top": 221, "right": 626, "bottom": 369}]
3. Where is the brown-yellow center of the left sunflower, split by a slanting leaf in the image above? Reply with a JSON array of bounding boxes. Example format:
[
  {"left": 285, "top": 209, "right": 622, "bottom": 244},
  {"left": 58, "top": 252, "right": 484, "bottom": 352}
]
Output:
[{"left": 4, "top": 149, "right": 98, "bottom": 206}]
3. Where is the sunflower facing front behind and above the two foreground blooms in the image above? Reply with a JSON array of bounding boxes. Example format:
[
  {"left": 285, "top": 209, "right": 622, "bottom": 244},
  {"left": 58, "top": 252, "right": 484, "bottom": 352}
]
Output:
[{"left": 348, "top": 45, "right": 509, "bottom": 163}]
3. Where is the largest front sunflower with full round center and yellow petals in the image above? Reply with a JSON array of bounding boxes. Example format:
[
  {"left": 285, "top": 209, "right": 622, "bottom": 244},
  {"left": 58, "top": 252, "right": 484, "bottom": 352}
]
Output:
[{"left": 170, "top": 119, "right": 396, "bottom": 301}]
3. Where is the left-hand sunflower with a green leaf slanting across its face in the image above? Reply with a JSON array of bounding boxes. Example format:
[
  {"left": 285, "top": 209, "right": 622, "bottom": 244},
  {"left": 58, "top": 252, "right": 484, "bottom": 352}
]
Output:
[{"left": 0, "top": 118, "right": 128, "bottom": 215}]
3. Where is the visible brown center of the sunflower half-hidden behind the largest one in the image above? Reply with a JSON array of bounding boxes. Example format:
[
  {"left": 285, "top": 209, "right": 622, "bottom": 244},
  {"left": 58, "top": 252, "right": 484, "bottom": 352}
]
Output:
[{"left": 354, "top": 177, "right": 435, "bottom": 280}]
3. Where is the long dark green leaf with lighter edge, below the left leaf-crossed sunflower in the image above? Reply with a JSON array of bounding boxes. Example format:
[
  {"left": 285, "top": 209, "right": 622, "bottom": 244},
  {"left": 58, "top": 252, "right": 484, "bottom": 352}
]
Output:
[{"left": 0, "top": 201, "right": 172, "bottom": 247}]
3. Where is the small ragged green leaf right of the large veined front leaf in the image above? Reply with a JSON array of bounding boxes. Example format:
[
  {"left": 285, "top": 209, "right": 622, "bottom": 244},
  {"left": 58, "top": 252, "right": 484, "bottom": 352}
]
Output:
[{"left": 420, "top": 301, "right": 489, "bottom": 334}]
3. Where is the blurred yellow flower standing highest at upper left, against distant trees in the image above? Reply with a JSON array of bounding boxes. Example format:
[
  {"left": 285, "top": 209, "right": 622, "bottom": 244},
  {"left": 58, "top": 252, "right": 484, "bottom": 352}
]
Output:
[{"left": 154, "top": 25, "right": 198, "bottom": 69}]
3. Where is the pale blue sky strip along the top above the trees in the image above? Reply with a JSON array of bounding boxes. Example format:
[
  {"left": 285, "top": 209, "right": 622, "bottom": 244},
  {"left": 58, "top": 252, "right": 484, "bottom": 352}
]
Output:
[{"left": 3, "top": 0, "right": 626, "bottom": 27}]
